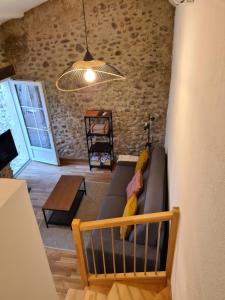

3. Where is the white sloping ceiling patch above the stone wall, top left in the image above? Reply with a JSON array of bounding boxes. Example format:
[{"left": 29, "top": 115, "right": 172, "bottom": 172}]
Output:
[{"left": 0, "top": 0, "right": 46, "bottom": 24}]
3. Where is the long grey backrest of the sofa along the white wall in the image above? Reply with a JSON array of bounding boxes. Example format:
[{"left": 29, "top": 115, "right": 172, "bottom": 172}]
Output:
[{"left": 129, "top": 147, "right": 165, "bottom": 246}]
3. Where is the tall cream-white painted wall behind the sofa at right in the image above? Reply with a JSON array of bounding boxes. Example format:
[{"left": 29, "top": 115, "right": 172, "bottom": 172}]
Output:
[{"left": 166, "top": 0, "right": 225, "bottom": 300}]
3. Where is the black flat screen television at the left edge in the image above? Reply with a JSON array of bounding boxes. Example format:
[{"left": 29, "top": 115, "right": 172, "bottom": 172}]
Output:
[{"left": 0, "top": 129, "right": 18, "bottom": 170}]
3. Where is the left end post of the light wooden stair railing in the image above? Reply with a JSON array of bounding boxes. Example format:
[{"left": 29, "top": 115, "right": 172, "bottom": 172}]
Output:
[{"left": 72, "top": 219, "right": 88, "bottom": 286}]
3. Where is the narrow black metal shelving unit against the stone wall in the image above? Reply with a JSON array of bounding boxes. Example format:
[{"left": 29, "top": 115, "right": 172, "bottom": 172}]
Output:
[{"left": 84, "top": 110, "right": 114, "bottom": 171}]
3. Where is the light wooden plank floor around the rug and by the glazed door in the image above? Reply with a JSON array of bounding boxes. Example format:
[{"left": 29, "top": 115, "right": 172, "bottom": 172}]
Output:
[{"left": 17, "top": 160, "right": 112, "bottom": 300}]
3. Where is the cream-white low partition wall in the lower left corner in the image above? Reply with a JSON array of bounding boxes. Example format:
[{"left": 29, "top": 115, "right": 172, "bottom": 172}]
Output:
[{"left": 0, "top": 179, "right": 58, "bottom": 300}]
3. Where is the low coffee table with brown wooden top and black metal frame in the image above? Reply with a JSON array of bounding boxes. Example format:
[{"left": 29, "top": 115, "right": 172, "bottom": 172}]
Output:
[{"left": 42, "top": 175, "right": 86, "bottom": 227}]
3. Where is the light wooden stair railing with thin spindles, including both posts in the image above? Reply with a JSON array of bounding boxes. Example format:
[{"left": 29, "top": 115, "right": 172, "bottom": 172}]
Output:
[{"left": 72, "top": 208, "right": 180, "bottom": 286}]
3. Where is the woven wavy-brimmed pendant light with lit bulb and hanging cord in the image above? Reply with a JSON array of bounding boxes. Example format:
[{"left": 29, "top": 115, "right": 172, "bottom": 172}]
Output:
[{"left": 56, "top": 0, "right": 125, "bottom": 92}]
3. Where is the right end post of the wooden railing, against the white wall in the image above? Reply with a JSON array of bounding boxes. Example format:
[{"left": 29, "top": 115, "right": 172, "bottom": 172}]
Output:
[{"left": 166, "top": 207, "right": 180, "bottom": 280}]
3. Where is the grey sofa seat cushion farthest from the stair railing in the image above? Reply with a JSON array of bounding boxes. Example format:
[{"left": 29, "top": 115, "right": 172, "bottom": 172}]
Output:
[{"left": 107, "top": 165, "right": 135, "bottom": 198}]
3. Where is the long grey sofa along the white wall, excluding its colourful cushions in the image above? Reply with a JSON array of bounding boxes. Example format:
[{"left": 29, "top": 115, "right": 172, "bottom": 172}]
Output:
[{"left": 85, "top": 147, "right": 167, "bottom": 274}]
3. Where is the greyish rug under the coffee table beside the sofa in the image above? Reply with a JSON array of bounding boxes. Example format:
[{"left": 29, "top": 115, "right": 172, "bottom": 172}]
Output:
[{"left": 39, "top": 181, "right": 109, "bottom": 250}]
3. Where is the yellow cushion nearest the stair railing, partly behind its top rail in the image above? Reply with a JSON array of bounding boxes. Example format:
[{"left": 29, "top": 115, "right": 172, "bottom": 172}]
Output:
[{"left": 120, "top": 194, "right": 137, "bottom": 240}]
